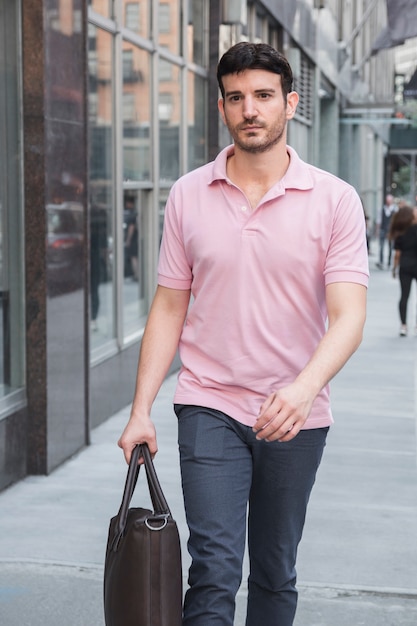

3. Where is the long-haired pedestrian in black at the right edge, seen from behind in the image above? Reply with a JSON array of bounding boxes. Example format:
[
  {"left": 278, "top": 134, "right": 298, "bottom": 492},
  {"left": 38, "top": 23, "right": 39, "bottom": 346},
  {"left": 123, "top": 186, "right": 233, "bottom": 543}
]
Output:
[{"left": 389, "top": 206, "right": 417, "bottom": 337}]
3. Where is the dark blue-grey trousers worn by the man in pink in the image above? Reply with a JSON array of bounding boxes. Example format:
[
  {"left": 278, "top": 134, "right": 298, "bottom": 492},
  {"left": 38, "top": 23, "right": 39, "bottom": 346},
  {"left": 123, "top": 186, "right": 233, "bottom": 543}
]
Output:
[{"left": 175, "top": 405, "right": 328, "bottom": 626}]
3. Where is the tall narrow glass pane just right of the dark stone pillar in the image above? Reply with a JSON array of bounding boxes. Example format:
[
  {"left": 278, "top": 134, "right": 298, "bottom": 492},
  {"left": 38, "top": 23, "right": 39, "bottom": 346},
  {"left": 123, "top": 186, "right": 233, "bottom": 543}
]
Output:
[{"left": 88, "top": 25, "right": 115, "bottom": 351}]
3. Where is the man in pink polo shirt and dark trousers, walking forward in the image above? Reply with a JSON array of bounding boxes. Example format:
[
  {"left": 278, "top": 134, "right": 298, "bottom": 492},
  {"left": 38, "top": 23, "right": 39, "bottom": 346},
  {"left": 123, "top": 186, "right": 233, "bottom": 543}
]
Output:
[{"left": 119, "top": 42, "right": 368, "bottom": 626}]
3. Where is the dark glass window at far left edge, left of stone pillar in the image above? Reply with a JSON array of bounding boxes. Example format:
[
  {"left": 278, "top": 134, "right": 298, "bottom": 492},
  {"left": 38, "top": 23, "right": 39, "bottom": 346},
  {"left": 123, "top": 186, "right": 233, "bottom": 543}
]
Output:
[{"left": 0, "top": 2, "right": 25, "bottom": 406}]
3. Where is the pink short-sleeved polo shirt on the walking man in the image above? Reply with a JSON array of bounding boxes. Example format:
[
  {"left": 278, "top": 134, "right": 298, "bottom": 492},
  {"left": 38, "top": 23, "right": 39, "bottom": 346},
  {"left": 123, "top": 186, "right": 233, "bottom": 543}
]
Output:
[{"left": 158, "top": 146, "right": 369, "bottom": 428}]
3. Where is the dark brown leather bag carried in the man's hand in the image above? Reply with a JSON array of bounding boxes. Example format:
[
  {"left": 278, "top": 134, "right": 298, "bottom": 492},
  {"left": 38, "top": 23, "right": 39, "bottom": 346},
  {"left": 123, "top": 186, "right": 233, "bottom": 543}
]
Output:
[{"left": 104, "top": 444, "right": 182, "bottom": 626}]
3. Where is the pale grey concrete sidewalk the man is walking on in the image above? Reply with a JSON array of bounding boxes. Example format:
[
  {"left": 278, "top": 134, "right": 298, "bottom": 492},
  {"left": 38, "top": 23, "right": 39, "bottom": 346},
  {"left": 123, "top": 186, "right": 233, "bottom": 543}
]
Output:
[{"left": 0, "top": 258, "right": 417, "bottom": 626}]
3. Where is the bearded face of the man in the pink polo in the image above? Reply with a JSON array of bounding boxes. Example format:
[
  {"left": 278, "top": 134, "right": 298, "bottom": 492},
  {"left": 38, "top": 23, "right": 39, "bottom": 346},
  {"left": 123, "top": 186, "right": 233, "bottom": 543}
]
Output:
[{"left": 219, "top": 70, "right": 298, "bottom": 154}]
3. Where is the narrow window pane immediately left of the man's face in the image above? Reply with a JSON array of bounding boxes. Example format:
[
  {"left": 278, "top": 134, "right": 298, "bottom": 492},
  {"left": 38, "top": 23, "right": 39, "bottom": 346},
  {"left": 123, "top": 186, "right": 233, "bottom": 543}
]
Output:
[{"left": 188, "top": 72, "right": 207, "bottom": 170}]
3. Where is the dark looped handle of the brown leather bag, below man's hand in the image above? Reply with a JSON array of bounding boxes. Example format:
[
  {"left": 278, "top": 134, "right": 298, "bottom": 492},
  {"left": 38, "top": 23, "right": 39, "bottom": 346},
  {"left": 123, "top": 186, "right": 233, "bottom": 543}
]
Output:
[{"left": 112, "top": 443, "right": 171, "bottom": 550}]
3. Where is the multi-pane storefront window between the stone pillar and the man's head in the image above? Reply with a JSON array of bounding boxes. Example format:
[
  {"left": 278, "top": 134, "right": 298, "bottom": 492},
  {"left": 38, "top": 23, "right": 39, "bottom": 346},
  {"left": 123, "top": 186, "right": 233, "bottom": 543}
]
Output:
[{"left": 88, "top": 0, "right": 209, "bottom": 356}]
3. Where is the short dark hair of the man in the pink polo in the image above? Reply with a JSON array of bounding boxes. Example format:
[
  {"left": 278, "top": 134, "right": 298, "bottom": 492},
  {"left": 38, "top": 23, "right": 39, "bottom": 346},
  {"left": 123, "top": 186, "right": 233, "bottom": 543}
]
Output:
[{"left": 217, "top": 41, "right": 293, "bottom": 100}]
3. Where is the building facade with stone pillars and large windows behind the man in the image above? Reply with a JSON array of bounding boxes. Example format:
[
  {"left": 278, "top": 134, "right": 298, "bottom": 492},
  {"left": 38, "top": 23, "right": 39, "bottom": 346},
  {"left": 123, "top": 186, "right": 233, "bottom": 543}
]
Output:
[{"left": 0, "top": 0, "right": 400, "bottom": 488}]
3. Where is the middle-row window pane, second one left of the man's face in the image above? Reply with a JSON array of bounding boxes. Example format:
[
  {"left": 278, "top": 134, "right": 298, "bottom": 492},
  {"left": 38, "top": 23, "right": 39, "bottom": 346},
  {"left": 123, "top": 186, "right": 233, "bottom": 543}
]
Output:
[{"left": 158, "top": 60, "right": 181, "bottom": 182}]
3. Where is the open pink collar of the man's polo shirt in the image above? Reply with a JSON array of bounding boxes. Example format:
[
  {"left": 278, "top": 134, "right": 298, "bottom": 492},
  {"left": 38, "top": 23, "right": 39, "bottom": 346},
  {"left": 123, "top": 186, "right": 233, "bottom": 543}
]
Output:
[{"left": 209, "top": 145, "right": 314, "bottom": 189}]
